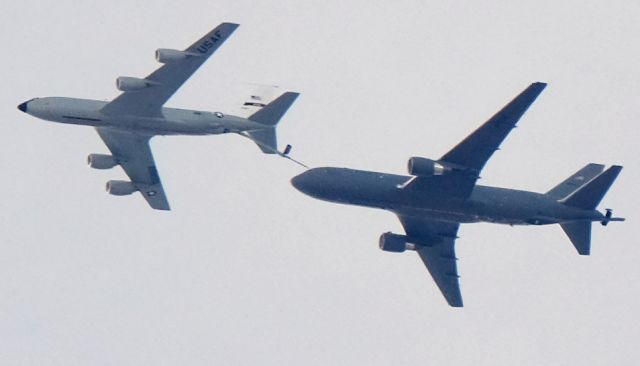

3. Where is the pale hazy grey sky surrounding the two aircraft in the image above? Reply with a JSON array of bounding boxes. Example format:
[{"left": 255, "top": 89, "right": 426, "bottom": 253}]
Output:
[{"left": 0, "top": 0, "right": 640, "bottom": 365}]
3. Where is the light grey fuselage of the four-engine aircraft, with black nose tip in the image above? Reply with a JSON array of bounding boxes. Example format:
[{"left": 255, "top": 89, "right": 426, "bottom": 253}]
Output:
[{"left": 19, "top": 97, "right": 264, "bottom": 136}]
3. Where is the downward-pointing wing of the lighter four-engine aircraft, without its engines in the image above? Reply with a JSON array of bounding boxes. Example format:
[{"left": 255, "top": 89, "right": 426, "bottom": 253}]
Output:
[{"left": 96, "top": 127, "right": 171, "bottom": 210}]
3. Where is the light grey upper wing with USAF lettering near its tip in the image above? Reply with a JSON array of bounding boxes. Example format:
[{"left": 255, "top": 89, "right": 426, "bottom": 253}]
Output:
[{"left": 102, "top": 23, "right": 239, "bottom": 116}]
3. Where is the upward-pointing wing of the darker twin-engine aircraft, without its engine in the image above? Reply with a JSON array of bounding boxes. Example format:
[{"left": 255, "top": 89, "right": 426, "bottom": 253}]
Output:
[{"left": 405, "top": 82, "right": 547, "bottom": 198}]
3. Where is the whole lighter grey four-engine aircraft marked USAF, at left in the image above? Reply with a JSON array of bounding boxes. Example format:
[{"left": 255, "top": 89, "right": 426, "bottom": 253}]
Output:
[{"left": 18, "top": 23, "right": 299, "bottom": 210}]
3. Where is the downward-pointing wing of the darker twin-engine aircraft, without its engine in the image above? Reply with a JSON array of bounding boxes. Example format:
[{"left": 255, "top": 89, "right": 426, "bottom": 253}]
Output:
[{"left": 398, "top": 214, "right": 462, "bottom": 307}]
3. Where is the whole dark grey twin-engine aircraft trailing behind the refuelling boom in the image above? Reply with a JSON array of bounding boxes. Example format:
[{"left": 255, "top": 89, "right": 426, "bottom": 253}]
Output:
[{"left": 291, "top": 82, "right": 624, "bottom": 307}]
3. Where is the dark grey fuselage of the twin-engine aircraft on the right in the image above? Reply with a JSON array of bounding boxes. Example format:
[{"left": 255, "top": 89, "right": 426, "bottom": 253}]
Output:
[{"left": 291, "top": 167, "right": 604, "bottom": 225}]
